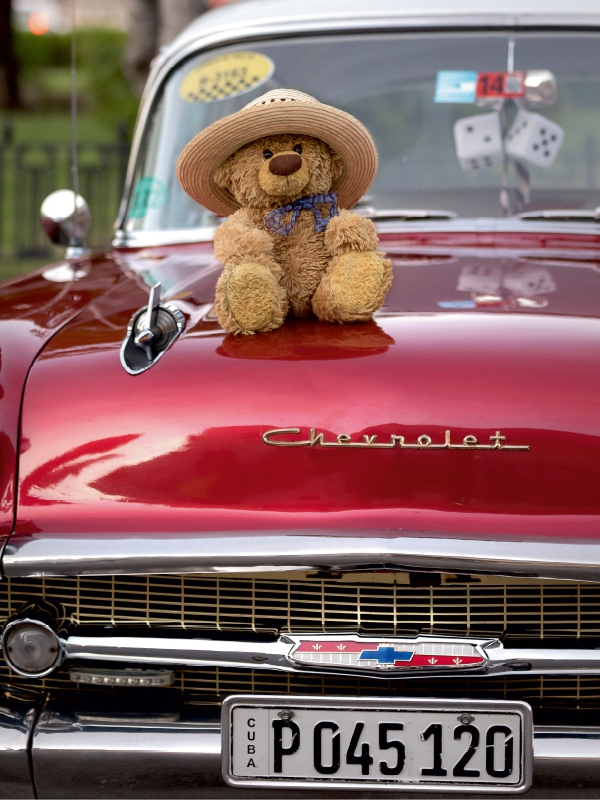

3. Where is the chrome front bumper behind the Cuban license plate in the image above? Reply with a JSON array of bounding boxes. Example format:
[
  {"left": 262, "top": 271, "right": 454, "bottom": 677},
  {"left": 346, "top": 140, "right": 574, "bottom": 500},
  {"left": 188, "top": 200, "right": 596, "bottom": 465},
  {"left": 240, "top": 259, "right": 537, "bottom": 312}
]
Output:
[{"left": 0, "top": 694, "right": 600, "bottom": 798}]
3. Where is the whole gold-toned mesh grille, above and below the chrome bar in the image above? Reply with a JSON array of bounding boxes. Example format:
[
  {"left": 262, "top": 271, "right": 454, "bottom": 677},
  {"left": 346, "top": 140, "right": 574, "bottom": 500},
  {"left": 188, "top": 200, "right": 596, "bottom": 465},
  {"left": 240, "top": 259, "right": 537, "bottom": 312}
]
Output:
[{"left": 0, "top": 573, "right": 600, "bottom": 709}]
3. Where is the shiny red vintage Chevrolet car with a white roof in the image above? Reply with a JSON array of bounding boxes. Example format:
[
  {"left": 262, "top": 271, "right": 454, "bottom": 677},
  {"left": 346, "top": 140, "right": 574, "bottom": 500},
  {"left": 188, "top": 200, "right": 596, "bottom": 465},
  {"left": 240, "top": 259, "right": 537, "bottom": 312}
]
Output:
[{"left": 0, "top": 0, "right": 600, "bottom": 798}]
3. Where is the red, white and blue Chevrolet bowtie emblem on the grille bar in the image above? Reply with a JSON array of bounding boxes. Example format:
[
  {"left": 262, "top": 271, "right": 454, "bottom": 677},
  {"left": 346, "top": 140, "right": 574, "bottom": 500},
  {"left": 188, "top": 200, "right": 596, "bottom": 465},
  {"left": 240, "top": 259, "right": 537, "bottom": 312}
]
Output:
[{"left": 286, "top": 634, "right": 494, "bottom": 674}]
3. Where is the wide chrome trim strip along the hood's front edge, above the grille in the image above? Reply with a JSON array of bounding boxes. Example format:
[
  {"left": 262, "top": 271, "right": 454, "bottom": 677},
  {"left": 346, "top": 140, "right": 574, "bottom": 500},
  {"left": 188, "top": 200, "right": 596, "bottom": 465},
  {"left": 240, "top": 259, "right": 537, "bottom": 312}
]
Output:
[{"left": 2, "top": 530, "right": 600, "bottom": 581}]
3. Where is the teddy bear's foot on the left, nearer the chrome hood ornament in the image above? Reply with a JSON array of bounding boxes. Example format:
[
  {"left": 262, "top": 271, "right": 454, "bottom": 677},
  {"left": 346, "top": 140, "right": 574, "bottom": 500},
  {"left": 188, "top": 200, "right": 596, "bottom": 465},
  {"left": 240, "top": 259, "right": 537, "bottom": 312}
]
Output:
[{"left": 225, "top": 262, "right": 287, "bottom": 334}]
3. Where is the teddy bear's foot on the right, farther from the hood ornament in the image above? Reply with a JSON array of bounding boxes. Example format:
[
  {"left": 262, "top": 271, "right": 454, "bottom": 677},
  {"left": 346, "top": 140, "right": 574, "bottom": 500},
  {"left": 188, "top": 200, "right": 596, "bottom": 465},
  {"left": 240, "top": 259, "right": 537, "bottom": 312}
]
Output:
[{"left": 312, "top": 251, "right": 392, "bottom": 322}]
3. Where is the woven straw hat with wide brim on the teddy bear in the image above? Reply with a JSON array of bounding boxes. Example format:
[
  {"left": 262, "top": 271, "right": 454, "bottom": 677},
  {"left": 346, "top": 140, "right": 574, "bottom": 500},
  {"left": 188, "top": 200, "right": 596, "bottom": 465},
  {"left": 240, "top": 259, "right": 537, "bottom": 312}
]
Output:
[{"left": 177, "top": 89, "right": 377, "bottom": 217}]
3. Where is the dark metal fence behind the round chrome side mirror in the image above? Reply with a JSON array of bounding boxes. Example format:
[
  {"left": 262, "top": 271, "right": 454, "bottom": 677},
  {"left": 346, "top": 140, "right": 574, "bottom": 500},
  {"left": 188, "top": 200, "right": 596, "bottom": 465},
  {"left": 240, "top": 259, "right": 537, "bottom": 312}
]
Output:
[{"left": 0, "top": 137, "right": 129, "bottom": 259}]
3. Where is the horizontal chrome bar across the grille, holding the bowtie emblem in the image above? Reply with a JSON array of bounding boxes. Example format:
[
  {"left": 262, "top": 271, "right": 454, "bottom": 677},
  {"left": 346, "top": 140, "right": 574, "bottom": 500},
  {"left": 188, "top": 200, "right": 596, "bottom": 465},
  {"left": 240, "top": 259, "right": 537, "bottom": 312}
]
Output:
[{"left": 54, "top": 634, "right": 600, "bottom": 680}]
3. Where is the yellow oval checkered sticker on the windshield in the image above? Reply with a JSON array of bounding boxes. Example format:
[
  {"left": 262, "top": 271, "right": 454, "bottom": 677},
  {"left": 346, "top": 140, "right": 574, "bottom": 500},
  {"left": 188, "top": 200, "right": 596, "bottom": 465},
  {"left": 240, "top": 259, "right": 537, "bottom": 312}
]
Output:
[{"left": 179, "top": 52, "right": 275, "bottom": 103}]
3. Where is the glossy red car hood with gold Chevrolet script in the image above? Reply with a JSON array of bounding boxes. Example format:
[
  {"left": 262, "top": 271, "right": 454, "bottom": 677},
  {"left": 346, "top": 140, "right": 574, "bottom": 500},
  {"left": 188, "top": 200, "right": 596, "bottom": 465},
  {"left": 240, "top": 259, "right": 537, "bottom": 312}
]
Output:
[{"left": 11, "top": 234, "right": 600, "bottom": 538}]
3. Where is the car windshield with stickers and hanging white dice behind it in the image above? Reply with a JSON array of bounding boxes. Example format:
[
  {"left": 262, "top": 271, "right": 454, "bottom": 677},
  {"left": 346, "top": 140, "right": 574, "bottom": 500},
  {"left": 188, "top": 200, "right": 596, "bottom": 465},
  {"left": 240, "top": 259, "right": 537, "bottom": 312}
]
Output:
[{"left": 126, "top": 32, "right": 600, "bottom": 231}]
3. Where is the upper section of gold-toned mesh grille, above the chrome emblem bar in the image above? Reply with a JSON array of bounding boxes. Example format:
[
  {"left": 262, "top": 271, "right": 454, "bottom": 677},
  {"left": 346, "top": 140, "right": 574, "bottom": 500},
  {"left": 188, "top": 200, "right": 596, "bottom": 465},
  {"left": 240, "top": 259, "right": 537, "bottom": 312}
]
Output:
[{"left": 0, "top": 573, "right": 600, "bottom": 639}]
